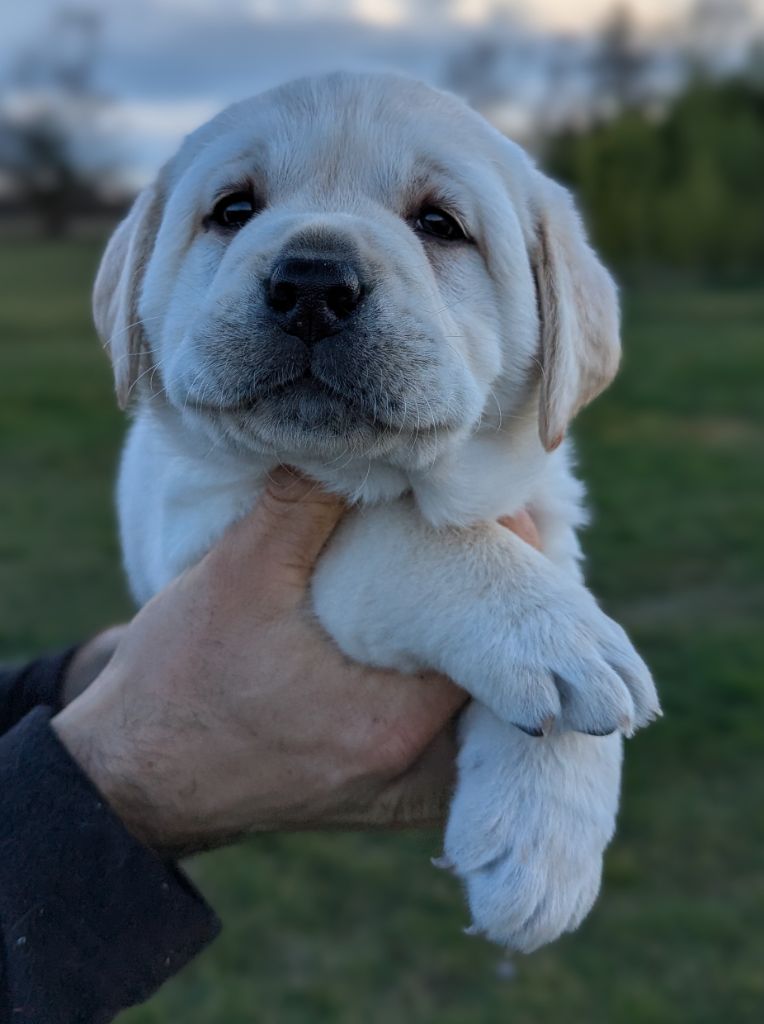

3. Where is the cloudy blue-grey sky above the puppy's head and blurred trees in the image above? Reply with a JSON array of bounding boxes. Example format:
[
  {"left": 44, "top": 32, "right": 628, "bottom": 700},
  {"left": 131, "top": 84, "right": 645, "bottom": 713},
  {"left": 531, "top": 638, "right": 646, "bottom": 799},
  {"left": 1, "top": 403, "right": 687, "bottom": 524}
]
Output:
[{"left": 0, "top": 0, "right": 764, "bottom": 183}]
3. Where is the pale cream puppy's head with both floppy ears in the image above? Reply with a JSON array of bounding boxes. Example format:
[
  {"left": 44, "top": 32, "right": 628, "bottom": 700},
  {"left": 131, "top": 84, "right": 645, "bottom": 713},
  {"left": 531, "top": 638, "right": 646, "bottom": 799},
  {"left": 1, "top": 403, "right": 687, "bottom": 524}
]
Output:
[{"left": 94, "top": 75, "right": 619, "bottom": 466}]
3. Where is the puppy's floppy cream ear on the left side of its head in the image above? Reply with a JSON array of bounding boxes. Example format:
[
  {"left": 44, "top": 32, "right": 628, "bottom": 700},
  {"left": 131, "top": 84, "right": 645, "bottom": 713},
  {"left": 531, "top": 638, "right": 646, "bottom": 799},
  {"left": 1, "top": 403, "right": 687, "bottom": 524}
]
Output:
[{"left": 93, "top": 185, "right": 162, "bottom": 409}]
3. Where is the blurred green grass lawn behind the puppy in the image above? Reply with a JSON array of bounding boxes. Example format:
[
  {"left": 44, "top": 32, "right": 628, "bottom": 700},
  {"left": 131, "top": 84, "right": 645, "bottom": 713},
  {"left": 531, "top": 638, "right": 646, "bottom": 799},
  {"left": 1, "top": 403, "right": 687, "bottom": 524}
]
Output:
[{"left": 0, "top": 235, "right": 764, "bottom": 1024}]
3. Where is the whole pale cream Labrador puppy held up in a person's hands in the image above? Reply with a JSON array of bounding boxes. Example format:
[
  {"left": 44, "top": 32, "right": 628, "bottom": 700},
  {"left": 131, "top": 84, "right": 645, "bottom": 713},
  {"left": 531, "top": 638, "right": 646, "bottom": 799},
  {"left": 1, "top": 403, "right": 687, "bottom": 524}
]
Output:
[{"left": 94, "top": 74, "right": 659, "bottom": 951}]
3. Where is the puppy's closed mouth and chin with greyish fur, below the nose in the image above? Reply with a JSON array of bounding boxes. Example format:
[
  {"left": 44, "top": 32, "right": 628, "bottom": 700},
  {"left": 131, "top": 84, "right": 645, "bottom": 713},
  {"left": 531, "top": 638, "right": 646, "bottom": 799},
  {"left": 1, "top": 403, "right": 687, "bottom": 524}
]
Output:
[{"left": 179, "top": 321, "right": 461, "bottom": 457}]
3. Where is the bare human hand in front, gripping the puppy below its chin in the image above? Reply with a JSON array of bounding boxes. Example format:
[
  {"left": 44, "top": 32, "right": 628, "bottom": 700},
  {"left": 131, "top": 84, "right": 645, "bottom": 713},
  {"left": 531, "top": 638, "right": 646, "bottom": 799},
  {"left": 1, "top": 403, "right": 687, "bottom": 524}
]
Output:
[{"left": 53, "top": 471, "right": 538, "bottom": 855}]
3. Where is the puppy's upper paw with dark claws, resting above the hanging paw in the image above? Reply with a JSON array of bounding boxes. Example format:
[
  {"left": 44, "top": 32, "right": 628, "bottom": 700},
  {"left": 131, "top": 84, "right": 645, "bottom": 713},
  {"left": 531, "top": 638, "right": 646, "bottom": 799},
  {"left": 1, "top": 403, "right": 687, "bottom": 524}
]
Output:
[{"left": 467, "top": 572, "right": 661, "bottom": 736}]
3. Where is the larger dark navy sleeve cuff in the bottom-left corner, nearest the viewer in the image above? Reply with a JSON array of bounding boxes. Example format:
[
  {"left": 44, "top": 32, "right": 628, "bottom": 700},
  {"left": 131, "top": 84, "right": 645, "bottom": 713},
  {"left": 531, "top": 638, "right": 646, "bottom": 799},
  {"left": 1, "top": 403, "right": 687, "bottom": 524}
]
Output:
[{"left": 0, "top": 708, "right": 219, "bottom": 1024}]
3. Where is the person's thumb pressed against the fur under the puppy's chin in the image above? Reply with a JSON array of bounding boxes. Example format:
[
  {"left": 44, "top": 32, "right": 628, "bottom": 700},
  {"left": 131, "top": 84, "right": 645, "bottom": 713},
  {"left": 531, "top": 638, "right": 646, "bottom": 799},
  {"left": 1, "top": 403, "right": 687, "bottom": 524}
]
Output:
[{"left": 222, "top": 466, "right": 346, "bottom": 591}]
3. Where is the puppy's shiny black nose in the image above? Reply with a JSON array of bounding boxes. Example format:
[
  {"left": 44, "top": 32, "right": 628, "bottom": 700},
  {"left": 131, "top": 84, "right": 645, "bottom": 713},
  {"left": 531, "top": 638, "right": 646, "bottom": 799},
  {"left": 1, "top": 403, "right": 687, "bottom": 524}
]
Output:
[{"left": 265, "top": 258, "right": 364, "bottom": 345}]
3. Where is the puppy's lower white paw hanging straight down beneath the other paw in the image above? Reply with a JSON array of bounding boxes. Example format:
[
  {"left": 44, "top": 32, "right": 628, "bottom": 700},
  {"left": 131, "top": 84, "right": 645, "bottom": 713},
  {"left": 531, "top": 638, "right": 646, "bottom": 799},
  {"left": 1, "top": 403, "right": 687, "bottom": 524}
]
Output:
[{"left": 444, "top": 708, "right": 621, "bottom": 953}]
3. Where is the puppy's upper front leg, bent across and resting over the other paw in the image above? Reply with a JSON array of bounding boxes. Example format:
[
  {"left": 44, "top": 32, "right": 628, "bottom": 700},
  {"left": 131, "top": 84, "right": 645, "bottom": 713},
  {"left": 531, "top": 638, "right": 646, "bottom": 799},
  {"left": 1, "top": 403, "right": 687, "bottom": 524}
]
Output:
[{"left": 313, "top": 501, "right": 659, "bottom": 735}]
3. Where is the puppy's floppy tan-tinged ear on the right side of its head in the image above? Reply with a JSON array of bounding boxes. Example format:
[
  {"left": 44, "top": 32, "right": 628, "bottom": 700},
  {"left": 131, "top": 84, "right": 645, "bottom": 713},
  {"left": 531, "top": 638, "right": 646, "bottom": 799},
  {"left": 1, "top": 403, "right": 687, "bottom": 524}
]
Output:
[{"left": 534, "top": 175, "right": 621, "bottom": 452}]
